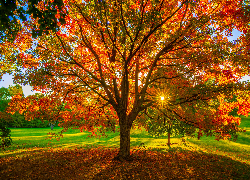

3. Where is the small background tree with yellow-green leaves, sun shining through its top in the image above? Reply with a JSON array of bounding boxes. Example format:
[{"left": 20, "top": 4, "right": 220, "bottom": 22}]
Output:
[{"left": 137, "top": 76, "right": 197, "bottom": 147}]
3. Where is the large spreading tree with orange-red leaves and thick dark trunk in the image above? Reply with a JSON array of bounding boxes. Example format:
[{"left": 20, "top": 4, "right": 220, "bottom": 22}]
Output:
[{"left": 6, "top": 0, "right": 250, "bottom": 160}]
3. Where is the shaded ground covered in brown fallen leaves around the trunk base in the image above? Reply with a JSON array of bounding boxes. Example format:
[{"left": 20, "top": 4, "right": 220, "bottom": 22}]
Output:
[{"left": 0, "top": 146, "right": 250, "bottom": 180}]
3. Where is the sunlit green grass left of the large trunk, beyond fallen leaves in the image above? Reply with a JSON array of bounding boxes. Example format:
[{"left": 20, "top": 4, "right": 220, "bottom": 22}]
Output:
[{"left": 0, "top": 127, "right": 119, "bottom": 156}]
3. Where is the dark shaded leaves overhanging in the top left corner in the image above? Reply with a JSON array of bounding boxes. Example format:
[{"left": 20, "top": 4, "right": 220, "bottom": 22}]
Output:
[{"left": 0, "top": 0, "right": 65, "bottom": 42}]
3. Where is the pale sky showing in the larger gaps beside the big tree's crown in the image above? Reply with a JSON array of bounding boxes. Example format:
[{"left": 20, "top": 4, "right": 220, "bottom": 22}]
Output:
[{"left": 0, "top": 27, "right": 250, "bottom": 97}]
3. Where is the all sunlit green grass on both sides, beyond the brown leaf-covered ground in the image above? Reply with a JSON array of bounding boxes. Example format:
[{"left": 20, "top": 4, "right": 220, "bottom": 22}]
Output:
[{"left": 0, "top": 117, "right": 250, "bottom": 161}]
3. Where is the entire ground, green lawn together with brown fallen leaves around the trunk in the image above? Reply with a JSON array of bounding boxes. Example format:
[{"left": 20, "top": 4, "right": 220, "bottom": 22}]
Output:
[{"left": 0, "top": 117, "right": 250, "bottom": 179}]
